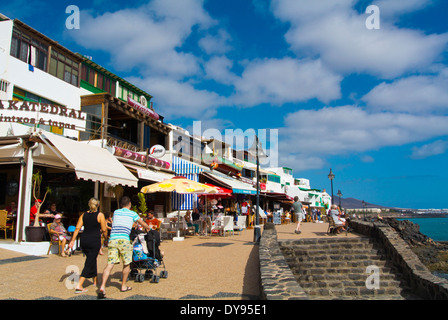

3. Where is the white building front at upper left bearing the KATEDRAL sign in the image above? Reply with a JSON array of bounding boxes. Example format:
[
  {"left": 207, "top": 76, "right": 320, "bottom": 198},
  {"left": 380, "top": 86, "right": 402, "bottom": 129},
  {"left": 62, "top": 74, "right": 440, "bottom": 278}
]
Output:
[{"left": 0, "top": 15, "right": 85, "bottom": 139}]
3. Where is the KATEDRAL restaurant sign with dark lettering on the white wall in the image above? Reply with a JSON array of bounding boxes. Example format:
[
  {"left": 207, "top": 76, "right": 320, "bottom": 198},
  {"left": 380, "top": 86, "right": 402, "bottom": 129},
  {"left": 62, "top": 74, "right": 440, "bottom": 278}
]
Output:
[{"left": 0, "top": 100, "right": 86, "bottom": 130}]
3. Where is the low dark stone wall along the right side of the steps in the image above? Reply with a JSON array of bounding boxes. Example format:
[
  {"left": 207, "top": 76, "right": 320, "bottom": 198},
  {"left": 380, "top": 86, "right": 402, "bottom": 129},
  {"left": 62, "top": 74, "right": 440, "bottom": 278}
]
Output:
[{"left": 350, "top": 220, "right": 448, "bottom": 300}]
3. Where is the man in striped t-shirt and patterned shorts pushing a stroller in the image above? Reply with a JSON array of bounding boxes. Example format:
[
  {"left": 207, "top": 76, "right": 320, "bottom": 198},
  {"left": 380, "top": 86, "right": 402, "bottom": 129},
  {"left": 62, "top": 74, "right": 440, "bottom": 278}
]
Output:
[{"left": 98, "top": 196, "right": 150, "bottom": 299}]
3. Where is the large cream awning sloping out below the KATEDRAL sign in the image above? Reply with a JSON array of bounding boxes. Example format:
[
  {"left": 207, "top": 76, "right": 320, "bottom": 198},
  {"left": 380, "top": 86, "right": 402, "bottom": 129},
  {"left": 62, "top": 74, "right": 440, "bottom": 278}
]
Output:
[{"left": 40, "top": 132, "right": 138, "bottom": 187}]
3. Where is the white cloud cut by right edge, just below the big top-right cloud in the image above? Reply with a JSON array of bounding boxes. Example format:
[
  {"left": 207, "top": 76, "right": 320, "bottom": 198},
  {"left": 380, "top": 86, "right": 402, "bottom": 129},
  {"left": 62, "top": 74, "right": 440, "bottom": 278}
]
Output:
[{"left": 363, "top": 69, "right": 448, "bottom": 113}]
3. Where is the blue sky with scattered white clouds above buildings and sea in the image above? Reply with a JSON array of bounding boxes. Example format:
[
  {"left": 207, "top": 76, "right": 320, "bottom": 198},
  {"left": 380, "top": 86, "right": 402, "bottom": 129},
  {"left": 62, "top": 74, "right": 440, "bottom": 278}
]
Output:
[{"left": 0, "top": 0, "right": 448, "bottom": 208}]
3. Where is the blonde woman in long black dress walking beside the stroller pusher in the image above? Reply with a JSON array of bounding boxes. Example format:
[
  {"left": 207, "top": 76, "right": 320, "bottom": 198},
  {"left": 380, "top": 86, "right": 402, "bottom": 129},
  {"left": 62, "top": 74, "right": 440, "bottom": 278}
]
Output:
[{"left": 69, "top": 198, "right": 107, "bottom": 293}]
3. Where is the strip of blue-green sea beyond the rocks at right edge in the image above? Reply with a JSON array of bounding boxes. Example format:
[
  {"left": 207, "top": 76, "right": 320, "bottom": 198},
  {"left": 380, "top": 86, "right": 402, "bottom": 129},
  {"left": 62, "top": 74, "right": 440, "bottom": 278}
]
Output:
[{"left": 397, "top": 216, "right": 448, "bottom": 279}]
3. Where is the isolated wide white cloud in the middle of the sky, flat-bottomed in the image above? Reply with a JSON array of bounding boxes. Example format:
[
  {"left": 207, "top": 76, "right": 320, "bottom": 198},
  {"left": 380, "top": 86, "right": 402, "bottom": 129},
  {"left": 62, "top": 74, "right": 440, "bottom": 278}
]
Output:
[{"left": 231, "top": 58, "right": 342, "bottom": 106}]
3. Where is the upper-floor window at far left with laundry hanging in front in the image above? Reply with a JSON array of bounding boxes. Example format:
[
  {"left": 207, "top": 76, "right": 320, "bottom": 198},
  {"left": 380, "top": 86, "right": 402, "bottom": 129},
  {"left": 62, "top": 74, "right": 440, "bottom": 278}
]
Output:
[{"left": 10, "top": 28, "right": 48, "bottom": 71}]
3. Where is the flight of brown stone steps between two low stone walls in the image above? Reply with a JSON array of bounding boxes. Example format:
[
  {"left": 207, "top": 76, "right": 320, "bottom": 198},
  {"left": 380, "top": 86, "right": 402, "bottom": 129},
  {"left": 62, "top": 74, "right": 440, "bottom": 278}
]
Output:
[{"left": 280, "top": 237, "right": 420, "bottom": 300}]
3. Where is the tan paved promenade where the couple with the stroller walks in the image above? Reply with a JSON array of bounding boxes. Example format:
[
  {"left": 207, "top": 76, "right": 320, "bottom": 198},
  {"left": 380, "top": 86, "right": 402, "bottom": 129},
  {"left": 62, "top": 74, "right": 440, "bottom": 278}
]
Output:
[{"left": 0, "top": 223, "right": 357, "bottom": 300}]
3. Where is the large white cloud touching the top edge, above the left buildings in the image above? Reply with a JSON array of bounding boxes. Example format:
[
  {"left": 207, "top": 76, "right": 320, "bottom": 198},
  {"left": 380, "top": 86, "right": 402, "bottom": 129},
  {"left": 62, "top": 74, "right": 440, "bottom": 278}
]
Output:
[{"left": 68, "top": 0, "right": 214, "bottom": 78}]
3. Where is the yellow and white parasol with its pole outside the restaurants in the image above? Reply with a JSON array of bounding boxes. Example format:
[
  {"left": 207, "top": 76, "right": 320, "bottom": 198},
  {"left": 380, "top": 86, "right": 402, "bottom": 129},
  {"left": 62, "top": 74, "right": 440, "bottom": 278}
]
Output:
[{"left": 140, "top": 176, "right": 218, "bottom": 240}]
